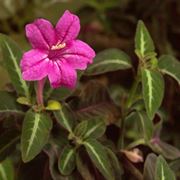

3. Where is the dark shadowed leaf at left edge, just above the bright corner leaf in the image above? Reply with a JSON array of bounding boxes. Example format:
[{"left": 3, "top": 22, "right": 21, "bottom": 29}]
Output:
[{"left": 0, "top": 130, "right": 20, "bottom": 161}]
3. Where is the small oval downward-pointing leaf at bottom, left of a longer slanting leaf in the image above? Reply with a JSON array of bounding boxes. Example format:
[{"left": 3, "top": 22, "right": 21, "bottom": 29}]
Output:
[{"left": 58, "top": 145, "right": 76, "bottom": 175}]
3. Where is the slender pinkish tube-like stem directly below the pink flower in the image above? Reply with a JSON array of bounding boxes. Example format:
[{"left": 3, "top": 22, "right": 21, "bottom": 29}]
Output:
[{"left": 36, "top": 78, "right": 46, "bottom": 107}]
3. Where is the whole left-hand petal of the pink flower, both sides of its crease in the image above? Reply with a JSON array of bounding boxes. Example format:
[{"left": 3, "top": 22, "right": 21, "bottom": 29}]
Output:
[{"left": 20, "top": 50, "right": 50, "bottom": 81}]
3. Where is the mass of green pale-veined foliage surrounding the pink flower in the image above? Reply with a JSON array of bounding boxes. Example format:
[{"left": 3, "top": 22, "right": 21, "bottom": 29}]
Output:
[{"left": 0, "top": 0, "right": 180, "bottom": 180}]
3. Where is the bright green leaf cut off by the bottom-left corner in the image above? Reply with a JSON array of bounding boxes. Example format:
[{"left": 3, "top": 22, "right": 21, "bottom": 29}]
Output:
[{"left": 0, "top": 158, "right": 14, "bottom": 180}]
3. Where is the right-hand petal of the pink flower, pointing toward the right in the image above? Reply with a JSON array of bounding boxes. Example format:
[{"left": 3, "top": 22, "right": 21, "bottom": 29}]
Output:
[{"left": 61, "top": 40, "right": 95, "bottom": 70}]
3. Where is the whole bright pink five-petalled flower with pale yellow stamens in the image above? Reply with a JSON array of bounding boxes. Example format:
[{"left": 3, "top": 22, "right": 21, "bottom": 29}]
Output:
[{"left": 20, "top": 11, "right": 95, "bottom": 88}]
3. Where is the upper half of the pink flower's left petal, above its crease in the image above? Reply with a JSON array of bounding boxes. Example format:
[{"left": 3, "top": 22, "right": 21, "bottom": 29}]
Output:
[{"left": 20, "top": 49, "right": 48, "bottom": 71}]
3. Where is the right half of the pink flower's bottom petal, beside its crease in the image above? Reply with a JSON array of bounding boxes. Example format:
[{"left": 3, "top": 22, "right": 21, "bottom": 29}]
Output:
[{"left": 58, "top": 60, "right": 77, "bottom": 89}]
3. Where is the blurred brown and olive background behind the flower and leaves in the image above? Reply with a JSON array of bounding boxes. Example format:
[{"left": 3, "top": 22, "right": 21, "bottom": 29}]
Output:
[{"left": 0, "top": 0, "right": 180, "bottom": 148}]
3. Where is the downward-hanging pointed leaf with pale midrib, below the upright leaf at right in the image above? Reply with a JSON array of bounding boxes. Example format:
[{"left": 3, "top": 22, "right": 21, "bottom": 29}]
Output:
[{"left": 142, "top": 69, "right": 164, "bottom": 119}]
